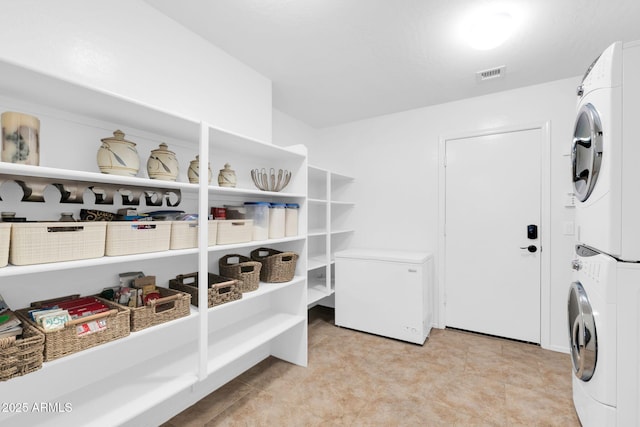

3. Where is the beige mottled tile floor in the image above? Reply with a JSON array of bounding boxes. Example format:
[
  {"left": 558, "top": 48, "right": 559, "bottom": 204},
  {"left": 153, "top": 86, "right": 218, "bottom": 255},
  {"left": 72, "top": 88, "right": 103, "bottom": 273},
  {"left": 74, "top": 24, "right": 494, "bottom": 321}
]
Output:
[{"left": 163, "top": 307, "right": 580, "bottom": 427}]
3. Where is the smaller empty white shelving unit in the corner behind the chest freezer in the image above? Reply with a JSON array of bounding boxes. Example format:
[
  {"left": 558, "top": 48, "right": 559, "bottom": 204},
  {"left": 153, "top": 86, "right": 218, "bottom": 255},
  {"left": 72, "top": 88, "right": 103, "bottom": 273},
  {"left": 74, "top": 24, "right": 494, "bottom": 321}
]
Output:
[{"left": 307, "top": 165, "right": 355, "bottom": 308}]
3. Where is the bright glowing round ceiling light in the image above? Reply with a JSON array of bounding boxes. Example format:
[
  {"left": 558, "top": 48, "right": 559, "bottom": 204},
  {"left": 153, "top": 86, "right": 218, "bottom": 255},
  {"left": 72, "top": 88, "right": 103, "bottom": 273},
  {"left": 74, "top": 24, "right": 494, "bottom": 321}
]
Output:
[{"left": 461, "top": 11, "right": 515, "bottom": 50}]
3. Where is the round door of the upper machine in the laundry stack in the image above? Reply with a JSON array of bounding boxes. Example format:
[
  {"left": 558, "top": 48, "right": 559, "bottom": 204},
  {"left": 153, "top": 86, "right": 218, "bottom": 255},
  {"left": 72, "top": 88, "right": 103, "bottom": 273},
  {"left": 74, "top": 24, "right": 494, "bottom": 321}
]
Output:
[{"left": 571, "top": 104, "right": 602, "bottom": 202}]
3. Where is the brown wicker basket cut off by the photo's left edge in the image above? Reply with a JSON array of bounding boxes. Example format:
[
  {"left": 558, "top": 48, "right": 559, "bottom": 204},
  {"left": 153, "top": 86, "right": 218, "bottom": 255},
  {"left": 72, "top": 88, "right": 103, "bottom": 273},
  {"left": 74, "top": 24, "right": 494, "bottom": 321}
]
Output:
[{"left": 0, "top": 316, "right": 44, "bottom": 381}]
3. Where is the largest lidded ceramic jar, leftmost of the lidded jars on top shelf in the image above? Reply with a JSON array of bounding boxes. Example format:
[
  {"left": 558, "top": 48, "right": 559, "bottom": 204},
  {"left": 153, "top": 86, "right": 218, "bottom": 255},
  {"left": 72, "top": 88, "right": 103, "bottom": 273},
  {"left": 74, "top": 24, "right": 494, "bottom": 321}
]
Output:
[{"left": 98, "top": 130, "right": 140, "bottom": 176}]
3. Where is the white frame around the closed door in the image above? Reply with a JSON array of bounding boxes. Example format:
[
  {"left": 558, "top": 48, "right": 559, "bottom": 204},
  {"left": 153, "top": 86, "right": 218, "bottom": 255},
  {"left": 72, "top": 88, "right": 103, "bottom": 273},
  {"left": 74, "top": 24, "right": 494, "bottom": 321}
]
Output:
[{"left": 434, "top": 121, "right": 551, "bottom": 348}]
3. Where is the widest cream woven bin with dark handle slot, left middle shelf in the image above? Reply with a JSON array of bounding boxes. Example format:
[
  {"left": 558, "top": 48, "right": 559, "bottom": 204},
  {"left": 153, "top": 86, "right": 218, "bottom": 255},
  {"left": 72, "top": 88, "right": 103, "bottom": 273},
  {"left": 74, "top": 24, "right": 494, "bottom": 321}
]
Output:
[{"left": 9, "top": 222, "right": 107, "bottom": 265}]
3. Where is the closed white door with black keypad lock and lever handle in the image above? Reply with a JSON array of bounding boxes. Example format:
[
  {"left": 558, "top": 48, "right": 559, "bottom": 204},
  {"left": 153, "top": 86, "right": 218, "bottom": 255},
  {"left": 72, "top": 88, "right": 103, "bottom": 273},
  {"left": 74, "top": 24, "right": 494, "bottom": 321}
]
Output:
[{"left": 444, "top": 129, "right": 543, "bottom": 343}]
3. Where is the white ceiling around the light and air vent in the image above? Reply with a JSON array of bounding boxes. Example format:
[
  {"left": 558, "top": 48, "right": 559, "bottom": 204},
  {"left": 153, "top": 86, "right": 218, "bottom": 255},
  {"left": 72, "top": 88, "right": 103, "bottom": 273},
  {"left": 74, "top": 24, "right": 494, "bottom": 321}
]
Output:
[{"left": 146, "top": 0, "right": 640, "bottom": 127}]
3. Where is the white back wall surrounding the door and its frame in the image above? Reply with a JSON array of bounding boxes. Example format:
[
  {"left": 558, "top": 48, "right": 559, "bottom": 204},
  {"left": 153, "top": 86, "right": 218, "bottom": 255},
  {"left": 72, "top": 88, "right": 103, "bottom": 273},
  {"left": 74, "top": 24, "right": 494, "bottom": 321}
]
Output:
[{"left": 296, "top": 77, "right": 579, "bottom": 351}]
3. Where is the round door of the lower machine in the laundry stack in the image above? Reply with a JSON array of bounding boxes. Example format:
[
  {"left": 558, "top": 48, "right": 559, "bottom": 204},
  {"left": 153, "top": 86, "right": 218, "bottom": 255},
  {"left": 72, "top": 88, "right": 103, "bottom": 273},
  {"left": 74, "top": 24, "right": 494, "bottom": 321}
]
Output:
[{"left": 568, "top": 282, "right": 598, "bottom": 381}]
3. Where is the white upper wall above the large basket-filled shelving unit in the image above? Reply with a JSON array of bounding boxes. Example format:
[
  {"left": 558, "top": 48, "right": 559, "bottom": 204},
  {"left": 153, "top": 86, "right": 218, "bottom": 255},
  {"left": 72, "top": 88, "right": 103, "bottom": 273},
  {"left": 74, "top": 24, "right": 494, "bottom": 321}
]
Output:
[{"left": 0, "top": 0, "right": 271, "bottom": 142}]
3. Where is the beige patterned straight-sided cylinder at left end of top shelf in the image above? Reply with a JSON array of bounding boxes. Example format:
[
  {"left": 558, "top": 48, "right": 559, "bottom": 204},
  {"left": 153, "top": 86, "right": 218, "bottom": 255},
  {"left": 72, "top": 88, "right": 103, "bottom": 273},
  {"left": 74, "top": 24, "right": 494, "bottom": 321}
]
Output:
[{"left": 0, "top": 111, "right": 40, "bottom": 166}]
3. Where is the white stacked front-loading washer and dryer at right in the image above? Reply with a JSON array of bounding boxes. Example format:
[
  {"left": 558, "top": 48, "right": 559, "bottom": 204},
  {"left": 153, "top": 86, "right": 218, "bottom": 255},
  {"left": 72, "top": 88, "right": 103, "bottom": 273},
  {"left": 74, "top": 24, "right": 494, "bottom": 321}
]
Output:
[{"left": 568, "top": 42, "right": 640, "bottom": 427}]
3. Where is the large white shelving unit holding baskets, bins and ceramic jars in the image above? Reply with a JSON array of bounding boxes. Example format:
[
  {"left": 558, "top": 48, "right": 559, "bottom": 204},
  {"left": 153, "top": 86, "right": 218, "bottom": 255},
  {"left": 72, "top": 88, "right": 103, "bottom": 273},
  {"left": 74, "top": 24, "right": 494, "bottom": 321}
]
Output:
[{"left": 0, "top": 58, "right": 307, "bottom": 426}]
